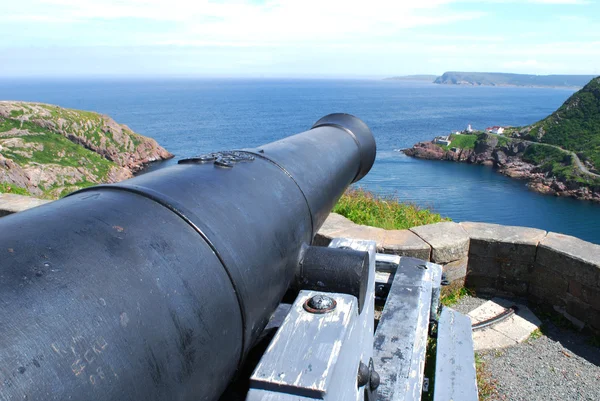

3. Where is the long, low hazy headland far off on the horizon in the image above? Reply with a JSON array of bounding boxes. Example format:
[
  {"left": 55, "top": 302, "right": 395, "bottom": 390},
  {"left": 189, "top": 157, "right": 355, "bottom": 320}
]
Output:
[{"left": 386, "top": 71, "right": 595, "bottom": 88}]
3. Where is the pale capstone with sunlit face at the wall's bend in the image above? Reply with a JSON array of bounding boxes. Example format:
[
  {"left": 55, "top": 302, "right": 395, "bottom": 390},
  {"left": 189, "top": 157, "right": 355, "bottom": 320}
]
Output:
[{"left": 410, "top": 221, "right": 469, "bottom": 263}]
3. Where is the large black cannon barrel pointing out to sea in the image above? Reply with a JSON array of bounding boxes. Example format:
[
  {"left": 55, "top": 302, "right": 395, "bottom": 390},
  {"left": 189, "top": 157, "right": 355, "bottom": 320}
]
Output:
[{"left": 0, "top": 114, "right": 375, "bottom": 400}]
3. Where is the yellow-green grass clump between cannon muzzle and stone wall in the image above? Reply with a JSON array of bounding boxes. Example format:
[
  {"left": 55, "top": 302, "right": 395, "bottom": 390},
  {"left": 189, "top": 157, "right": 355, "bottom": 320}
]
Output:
[{"left": 333, "top": 189, "right": 449, "bottom": 230}]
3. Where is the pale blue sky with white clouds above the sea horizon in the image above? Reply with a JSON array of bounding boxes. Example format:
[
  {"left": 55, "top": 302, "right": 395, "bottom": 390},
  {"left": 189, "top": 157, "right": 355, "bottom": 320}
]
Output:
[{"left": 0, "top": 0, "right": 600, "bottom": 78}]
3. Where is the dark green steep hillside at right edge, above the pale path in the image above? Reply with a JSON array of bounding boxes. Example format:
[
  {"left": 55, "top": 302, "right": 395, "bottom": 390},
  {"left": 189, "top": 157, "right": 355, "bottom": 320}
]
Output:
[{"left": 525, "top": 77, "right": 600, "bottom": 172}]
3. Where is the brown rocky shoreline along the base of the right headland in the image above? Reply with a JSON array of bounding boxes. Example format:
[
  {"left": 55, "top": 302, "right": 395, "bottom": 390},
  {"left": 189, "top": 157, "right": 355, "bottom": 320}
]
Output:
[{"left": 402, "top": 135, "right": 600, "bottom": 202}]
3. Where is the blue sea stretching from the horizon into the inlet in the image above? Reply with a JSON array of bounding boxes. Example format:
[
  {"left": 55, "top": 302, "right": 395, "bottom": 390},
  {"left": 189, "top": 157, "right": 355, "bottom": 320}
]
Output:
[{"left": 0, "top": 79, "right": 600, "bottom": 244}]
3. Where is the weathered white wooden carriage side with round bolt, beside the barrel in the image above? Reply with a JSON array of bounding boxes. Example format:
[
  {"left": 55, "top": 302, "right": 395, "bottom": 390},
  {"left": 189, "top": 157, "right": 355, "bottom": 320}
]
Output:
[{"left": 246, "top": 239, "right": 379, "bottom": 401}]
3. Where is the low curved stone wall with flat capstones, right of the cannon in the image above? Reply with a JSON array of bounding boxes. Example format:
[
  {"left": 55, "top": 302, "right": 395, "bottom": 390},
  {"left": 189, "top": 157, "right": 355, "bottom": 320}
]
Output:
[{"left": 316, "top": 213, "right": 600, "bottom": 333}]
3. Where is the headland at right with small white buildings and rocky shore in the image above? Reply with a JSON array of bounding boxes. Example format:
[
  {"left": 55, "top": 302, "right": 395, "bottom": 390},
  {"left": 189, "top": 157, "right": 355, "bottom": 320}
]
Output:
[{"left": 403, "top": 77, "right": 600, "bottom": 202}]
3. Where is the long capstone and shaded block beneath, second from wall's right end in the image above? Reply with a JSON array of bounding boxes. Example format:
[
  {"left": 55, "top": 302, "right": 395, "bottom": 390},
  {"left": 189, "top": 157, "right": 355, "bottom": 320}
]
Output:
[{"left": 460, "top": 222, "right": 546, "bottom": 262}]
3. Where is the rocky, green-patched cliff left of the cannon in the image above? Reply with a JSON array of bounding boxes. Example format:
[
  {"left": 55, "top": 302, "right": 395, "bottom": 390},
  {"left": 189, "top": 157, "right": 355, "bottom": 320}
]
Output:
[{"left": 0, "top": 101, "right": 173, "bottom": 198}]
